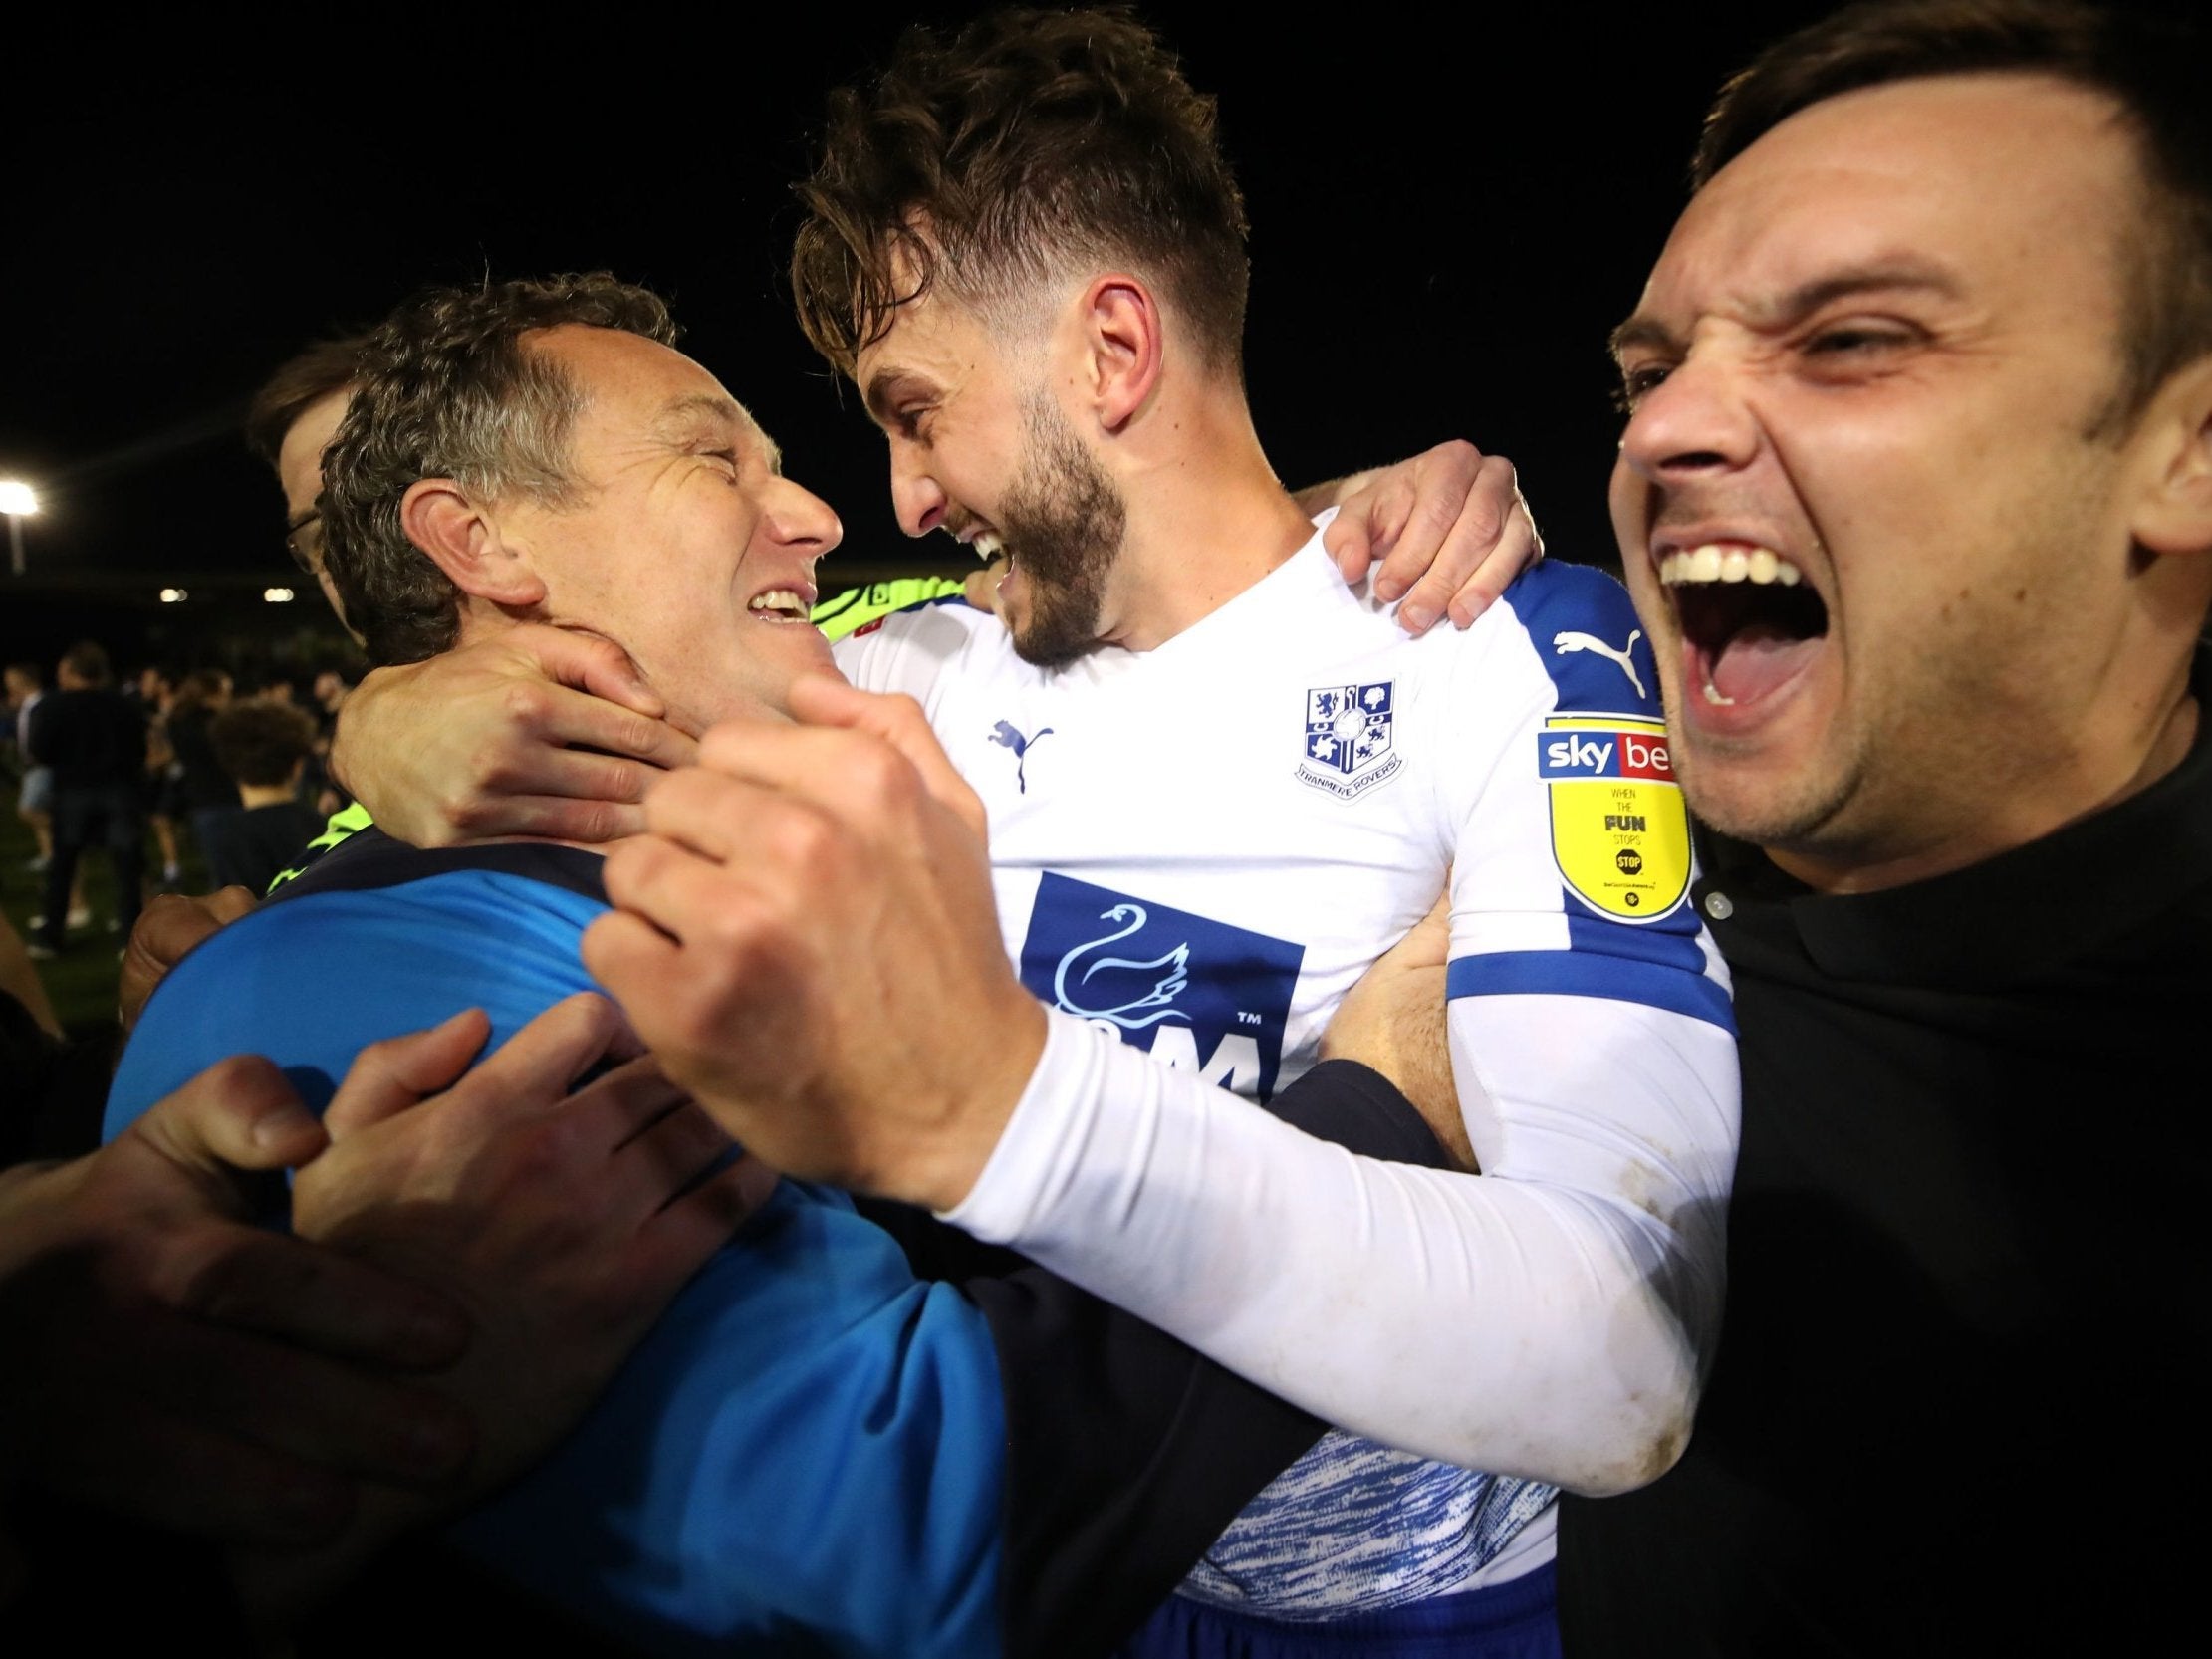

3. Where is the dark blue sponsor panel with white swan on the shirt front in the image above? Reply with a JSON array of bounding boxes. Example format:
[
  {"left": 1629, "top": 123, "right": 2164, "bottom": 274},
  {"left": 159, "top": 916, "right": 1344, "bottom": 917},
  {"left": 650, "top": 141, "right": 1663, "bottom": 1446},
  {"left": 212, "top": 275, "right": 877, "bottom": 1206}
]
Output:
[{"left": 1022, "top": 871, "right": 1305, "bottom": 1099}]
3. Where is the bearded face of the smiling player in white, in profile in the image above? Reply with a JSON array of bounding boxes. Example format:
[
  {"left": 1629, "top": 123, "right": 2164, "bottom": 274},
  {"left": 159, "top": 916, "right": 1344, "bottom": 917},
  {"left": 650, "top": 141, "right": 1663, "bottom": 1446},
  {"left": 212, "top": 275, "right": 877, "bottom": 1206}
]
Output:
[{"left": 854, "top": 292, "right": 1128, "bottom": 666}]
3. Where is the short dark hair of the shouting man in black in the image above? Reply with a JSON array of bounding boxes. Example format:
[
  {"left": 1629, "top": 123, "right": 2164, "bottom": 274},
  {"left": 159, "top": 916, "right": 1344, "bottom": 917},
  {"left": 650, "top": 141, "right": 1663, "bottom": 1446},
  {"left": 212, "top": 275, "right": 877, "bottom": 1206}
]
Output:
[{"left": 1690, "top": 0, "right": 2212, "bottom": 420}]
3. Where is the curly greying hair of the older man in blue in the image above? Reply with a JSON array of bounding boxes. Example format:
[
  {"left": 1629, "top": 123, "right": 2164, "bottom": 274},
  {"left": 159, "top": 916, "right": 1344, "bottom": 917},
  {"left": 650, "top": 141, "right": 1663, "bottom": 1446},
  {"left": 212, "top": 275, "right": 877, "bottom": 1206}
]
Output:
[{"left": 323, "top": 270, "right": 677, "bottom": 666}]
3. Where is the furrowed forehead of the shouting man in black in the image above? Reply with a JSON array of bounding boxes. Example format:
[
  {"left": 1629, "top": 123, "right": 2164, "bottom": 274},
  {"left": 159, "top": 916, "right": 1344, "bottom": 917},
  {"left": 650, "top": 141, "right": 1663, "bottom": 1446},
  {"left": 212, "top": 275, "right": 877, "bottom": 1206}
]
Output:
[{"left": 1645, "top": 73, "right": 2141, "bottom": 321}]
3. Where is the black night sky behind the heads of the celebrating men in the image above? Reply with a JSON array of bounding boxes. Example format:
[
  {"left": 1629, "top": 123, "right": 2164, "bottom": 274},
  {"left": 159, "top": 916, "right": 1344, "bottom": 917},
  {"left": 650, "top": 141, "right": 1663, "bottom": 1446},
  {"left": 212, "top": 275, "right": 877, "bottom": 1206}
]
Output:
[{"left": 0, "top": 4, "right": 1821, "bottom": 654}]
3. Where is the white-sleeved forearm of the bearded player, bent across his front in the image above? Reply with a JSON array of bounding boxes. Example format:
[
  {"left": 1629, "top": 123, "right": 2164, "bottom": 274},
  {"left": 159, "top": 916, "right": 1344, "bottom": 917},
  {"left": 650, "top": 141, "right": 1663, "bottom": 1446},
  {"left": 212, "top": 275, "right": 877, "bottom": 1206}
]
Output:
[{"left": 951, "top": 1020, "right": 1732, "bottom": 1493}]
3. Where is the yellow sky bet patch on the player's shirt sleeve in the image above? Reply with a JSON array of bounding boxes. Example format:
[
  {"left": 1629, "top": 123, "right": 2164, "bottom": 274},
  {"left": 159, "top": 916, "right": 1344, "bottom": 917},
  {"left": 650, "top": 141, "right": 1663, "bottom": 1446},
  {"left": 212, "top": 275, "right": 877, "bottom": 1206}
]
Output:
[{"left": 1535, "top": 714, "right": 1690, "bottom": 922}]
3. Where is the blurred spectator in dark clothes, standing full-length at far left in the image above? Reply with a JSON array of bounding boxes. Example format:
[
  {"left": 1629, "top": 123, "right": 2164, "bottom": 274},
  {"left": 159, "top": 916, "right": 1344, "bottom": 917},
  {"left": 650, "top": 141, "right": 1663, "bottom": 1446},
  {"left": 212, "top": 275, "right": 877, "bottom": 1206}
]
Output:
[{"left": 29, "top": 643, "right": 146, "bottom": 956}]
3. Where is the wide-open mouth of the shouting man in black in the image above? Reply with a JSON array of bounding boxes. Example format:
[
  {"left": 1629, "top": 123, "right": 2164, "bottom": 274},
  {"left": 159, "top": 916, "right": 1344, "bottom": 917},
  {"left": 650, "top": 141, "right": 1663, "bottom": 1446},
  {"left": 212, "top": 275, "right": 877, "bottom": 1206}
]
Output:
[{"left": 1659, "top": 542, "right": 1828, "bottom": 708}]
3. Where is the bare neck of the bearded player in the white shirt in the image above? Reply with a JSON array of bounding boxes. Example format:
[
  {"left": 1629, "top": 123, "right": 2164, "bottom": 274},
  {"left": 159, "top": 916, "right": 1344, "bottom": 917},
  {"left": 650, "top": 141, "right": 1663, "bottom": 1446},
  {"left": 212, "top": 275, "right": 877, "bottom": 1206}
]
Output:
[{"left": 1104, "top": 382, "right": 1314, "bottom": 650}]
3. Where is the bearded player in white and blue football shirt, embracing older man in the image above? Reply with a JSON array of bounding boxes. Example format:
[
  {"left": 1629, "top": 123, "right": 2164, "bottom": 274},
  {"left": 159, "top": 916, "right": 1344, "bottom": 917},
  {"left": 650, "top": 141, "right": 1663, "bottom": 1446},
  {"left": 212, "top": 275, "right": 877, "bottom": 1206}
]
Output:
[{"left": 591, "top": 13, "right": 1736, "bottom": 1652}]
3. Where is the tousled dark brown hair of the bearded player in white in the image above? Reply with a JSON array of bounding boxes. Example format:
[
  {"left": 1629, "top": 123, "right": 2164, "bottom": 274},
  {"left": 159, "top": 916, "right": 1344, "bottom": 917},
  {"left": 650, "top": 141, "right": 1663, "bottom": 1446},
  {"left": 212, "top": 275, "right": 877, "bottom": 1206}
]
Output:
[{"left": 792, "top": 7, "right": 1250, "bottom": 373}]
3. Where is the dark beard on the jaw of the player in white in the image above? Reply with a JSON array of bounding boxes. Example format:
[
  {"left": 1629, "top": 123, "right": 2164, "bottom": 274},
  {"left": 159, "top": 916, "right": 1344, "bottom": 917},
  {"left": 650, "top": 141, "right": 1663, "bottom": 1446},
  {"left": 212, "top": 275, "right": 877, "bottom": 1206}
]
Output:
[{"left": 998, "top": 391, "right": 1128, "bottom": 668}]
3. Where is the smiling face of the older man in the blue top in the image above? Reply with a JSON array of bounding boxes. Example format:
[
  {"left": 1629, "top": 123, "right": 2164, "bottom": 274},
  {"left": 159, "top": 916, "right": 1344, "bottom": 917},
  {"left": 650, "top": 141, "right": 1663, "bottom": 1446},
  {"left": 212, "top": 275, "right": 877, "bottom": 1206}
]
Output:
[{"left": 500, "top": 326, "right": 841, "bottom": 730}]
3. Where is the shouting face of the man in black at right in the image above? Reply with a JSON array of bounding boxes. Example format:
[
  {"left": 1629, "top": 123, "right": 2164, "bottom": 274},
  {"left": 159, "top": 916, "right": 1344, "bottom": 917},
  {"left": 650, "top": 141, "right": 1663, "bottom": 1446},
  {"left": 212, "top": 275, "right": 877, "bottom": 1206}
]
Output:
[{"left": 1612, "top": 76, "right": 2167, "bottom": 884}]
